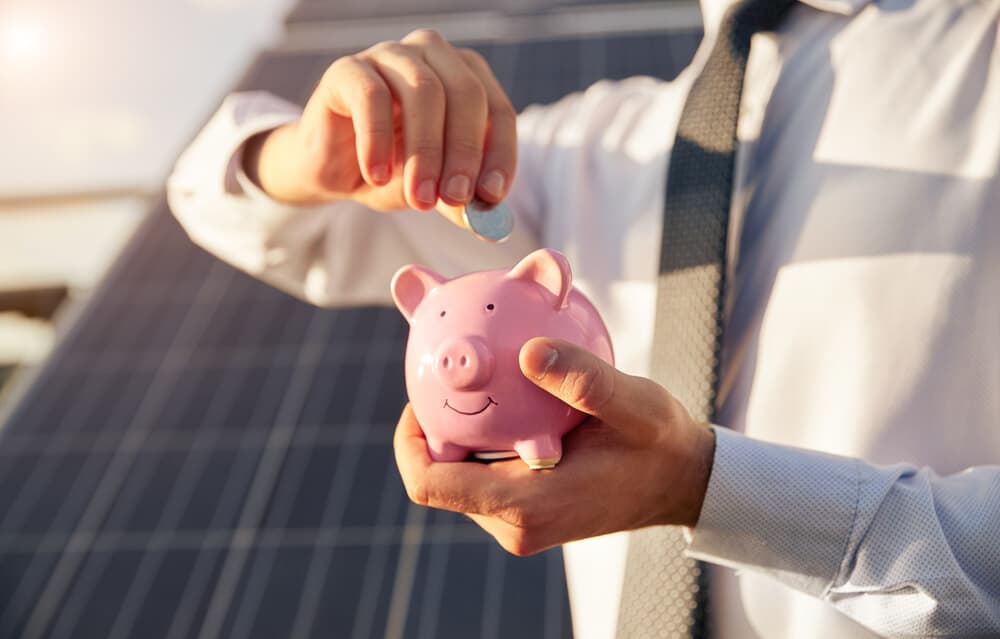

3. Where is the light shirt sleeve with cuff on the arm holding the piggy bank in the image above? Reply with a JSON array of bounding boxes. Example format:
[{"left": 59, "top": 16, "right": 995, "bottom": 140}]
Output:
[{"left": 688, "top": 428, "right": 1000, "bottom": 637}]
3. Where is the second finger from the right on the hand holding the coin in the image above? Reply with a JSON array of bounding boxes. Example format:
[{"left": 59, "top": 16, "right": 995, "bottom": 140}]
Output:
[{"left": 403, "top": 29, "right": 487, "bottom": 205}]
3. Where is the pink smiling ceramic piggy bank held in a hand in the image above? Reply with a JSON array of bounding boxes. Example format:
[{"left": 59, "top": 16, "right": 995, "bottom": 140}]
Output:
[{"left": 392, "top": 249, "right": 614, "bottom": 469}]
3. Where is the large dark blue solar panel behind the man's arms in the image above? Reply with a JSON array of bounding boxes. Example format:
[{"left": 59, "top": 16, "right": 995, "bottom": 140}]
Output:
[{"left": 0, "top": 25, "right": 698, "bottom": 639}]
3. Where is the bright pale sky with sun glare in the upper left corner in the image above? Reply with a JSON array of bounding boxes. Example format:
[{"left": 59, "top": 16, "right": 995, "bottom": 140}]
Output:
[{"left": 0, "top": 0, "right": 291, "bottom": 201}]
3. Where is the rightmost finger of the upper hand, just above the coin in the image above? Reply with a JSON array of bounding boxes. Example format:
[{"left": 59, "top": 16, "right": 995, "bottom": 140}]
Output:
[{"left": 459, "top": 49, "right": 517, "bottom": 202}]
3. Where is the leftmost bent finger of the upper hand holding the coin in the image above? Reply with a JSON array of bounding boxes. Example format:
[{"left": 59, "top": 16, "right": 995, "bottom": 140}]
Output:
[{"left": 319, "top": 56, "right": 394, "bottom": 186}]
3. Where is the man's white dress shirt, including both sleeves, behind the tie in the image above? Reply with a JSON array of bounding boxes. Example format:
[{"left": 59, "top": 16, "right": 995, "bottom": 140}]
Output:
[{"left": 169, "top": 0, "right": 1000, "bottom": 639}]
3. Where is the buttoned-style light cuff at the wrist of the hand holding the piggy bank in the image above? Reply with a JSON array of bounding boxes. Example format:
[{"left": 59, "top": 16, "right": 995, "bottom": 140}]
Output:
[{"left": 688, "top": 427, "right": 860, "bottom": 596}]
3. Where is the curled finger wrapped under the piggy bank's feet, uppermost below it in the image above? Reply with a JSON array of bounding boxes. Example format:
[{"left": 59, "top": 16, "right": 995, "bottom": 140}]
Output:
[{"left": 393, "top": 405, "right": 527, "bottom": 515}]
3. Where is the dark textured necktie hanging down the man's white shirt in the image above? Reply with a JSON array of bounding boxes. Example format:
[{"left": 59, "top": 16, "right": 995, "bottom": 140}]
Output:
[{"left": 618, "top": 0, "right": 793, "bottom": 639}]
